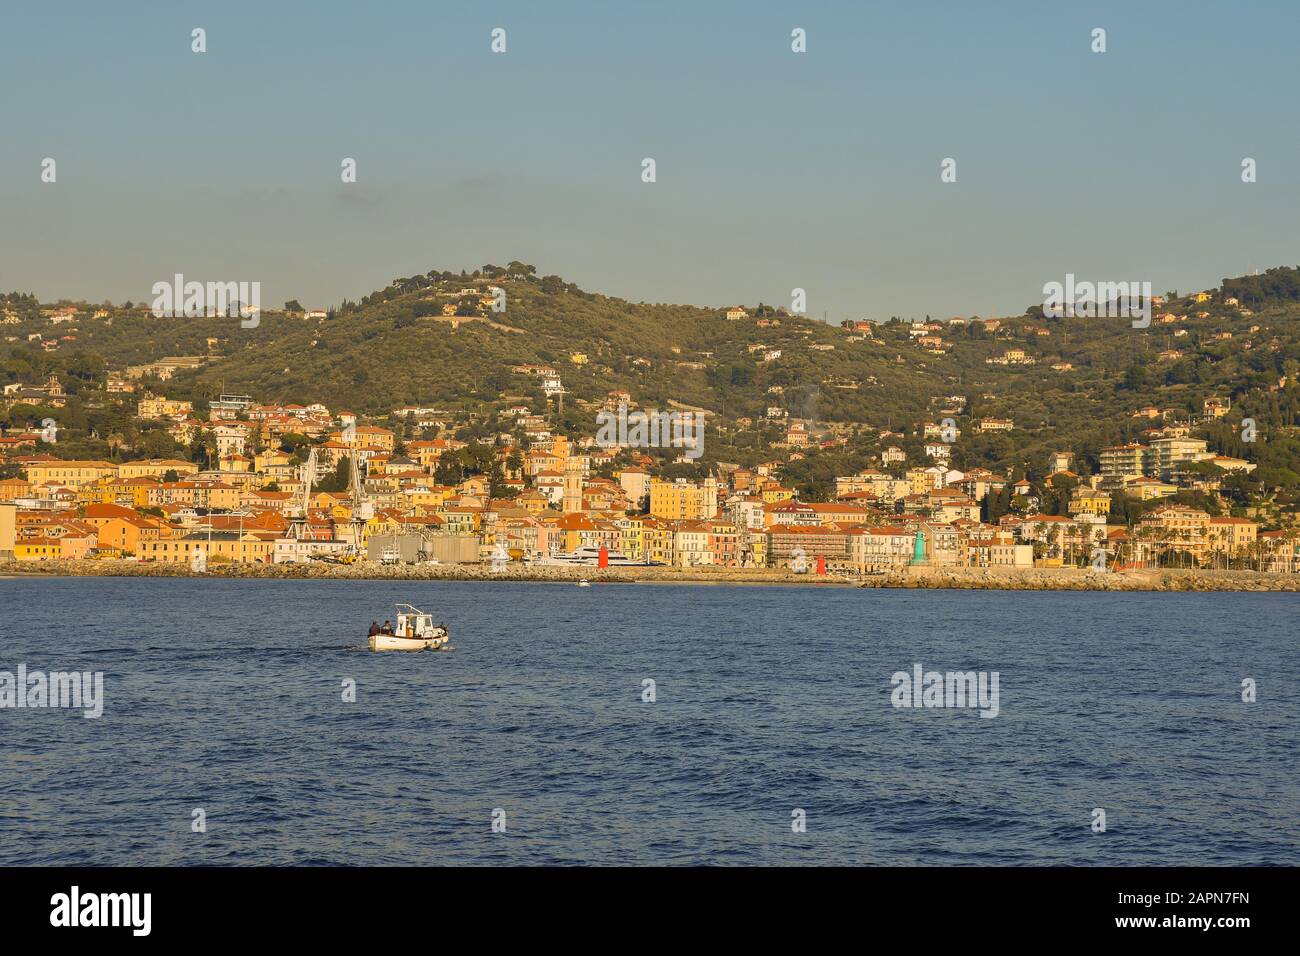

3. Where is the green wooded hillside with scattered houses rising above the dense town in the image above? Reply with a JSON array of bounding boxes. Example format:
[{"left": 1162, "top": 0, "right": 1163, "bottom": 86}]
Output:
[{"left": 3, "top": 263, "right": 1300, "bottom": 494}]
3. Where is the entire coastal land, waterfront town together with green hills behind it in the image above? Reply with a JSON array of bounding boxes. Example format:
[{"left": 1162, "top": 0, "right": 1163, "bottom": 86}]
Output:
[{"left": 0, "top": 261, "right": 1300, "bottom": 579}]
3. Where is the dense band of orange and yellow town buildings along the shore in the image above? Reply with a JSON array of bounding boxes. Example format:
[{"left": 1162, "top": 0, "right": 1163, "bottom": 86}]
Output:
[{"left": 0, "top": 365, "right": 1300, "bottom": 576}]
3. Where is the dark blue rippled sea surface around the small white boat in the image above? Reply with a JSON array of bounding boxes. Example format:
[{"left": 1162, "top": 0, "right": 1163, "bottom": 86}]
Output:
[{"left": 0, "top": 578, "right": 1300, "bottom": 865}]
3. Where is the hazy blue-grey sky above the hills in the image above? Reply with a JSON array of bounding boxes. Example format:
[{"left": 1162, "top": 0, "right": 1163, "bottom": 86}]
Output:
[{"left": 0, "top": 0, "right": 1300, "bottom": 321}]
